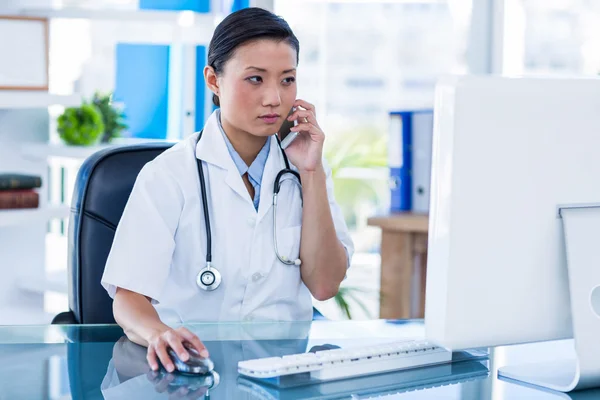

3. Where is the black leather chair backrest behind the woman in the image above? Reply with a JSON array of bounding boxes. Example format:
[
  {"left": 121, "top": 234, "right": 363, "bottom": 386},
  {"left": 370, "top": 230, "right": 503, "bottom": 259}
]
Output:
[{"left": 68, "top": 142, "right": 173, "bottom": 324}]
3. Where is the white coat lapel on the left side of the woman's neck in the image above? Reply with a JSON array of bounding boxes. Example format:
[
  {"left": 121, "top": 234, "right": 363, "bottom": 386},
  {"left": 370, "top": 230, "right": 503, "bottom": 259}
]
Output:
[{"left": 196, "top": 112, "right": 254, "bottom": 208}]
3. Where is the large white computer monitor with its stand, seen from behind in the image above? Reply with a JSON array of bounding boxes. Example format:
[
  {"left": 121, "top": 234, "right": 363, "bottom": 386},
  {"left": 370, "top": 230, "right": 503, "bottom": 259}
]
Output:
[{"left": 425, "top": 76, "right": 600, "bottom": 392}]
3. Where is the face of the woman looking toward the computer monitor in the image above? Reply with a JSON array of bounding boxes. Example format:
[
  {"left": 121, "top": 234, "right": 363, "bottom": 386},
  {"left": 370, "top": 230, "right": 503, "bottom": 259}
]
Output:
[{"left": 205, "top": 40, "right": 297, "bottom": 136}]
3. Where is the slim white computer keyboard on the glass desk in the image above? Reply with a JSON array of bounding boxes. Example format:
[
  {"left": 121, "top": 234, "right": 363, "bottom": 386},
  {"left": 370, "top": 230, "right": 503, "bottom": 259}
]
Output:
[{"left": 238, "top": 340, "right": 452, "bottom": 380}]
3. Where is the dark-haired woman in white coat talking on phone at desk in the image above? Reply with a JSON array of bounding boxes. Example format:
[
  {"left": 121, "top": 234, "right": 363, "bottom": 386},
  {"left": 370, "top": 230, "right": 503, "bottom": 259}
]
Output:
[{"left": 102, "top": 8, "right": 353, "bottom": 371}]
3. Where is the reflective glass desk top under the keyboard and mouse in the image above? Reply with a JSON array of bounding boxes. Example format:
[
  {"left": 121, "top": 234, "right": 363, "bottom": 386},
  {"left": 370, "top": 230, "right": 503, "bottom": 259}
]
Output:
[{"left": 0, "top": 320, "right": 600, "bottom": 400}]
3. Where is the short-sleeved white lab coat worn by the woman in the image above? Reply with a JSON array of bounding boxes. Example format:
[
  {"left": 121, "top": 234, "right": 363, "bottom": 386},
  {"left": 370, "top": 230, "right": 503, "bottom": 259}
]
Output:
[{"left": 102, "top": 112, "right": 353, "bottom": 325}]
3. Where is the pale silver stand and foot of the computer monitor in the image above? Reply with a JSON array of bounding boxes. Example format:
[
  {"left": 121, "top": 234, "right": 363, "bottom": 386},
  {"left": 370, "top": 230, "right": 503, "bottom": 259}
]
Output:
[{"left": 498, "top": 204, "right": 600, "bottom": 392}]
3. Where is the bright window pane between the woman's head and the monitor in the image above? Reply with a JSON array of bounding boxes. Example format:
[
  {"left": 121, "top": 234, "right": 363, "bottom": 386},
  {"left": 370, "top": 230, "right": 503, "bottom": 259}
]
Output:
[{"left": 275, "top": 0, "right": 471, "bottom": 247}]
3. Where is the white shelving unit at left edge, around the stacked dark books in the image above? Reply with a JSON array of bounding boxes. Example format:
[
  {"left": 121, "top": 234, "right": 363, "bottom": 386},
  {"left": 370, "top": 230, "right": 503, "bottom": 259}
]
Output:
[{"left": 0, "top": 90, "right": 77, "bottom": 324}]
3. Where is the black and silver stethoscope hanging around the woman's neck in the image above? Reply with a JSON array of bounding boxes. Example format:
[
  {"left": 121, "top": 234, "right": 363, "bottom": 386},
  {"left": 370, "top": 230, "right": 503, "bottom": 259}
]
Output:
[{"left": 196, "top": 131, "right": 302, "bottom": 291}]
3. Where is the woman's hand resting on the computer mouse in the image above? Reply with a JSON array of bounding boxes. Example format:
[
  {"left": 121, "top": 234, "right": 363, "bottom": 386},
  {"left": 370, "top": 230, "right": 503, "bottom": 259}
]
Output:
[{"left": 146, "top": 327, "right": 208, "bottom": 372}]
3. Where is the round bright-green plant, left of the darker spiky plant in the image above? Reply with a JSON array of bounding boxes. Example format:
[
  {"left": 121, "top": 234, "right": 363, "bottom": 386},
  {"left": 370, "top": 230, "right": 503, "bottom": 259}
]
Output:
[{"left": 57, "top": 103, "right": 104, "bottom": 146}]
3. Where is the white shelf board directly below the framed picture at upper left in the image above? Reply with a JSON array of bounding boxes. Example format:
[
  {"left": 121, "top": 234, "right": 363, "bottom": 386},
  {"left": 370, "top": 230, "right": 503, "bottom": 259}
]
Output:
[{"left": 0, "top": 90, "right": 82, "bottom": 109}]
